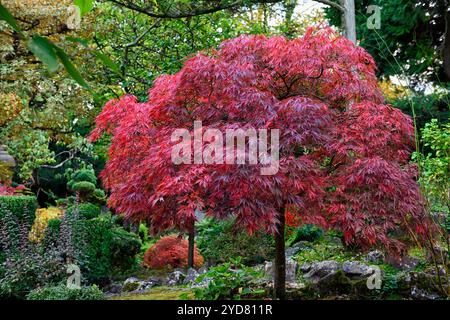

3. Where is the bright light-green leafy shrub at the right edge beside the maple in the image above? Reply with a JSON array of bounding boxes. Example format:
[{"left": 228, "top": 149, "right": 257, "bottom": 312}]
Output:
[{"left": 414, "top": 119, "right": 450, "bottom": 214}]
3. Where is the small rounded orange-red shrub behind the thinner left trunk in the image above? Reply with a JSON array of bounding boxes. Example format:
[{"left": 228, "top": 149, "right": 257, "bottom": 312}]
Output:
[{"left": 144, "top": 236, "right": 203, "bottom": 269}]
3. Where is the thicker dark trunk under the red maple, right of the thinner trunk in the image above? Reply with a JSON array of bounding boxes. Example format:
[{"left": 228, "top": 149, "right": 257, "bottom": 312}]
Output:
[{"left": 274, "top": 208, "right": 286, "bottom": 300}]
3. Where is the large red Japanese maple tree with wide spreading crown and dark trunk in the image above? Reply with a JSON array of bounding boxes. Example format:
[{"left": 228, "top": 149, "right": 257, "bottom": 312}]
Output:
[{"left": 91, "top": 29, "right": 425, "bottom": 298}]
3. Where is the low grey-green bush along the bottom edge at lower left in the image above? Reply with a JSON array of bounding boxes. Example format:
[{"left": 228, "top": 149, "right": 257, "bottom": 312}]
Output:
[{"left": 27, "top": 284, "right": 105, "bottom": 300}]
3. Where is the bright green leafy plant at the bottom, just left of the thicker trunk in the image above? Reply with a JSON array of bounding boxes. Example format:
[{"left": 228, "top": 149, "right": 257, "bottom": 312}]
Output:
[{"left": 194, "top": 258, "right": 265, "bottom": 300}]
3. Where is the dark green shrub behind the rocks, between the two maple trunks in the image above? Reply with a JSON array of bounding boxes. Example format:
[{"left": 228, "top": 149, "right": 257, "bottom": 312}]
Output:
[{"left": 196, "top": 218, "right": 274, "bottom": 264}]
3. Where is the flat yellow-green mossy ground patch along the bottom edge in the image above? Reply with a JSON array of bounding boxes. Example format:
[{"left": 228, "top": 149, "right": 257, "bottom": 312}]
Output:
[{"left": 111, "top": 287, "right": 194, "bottom": 300}]
